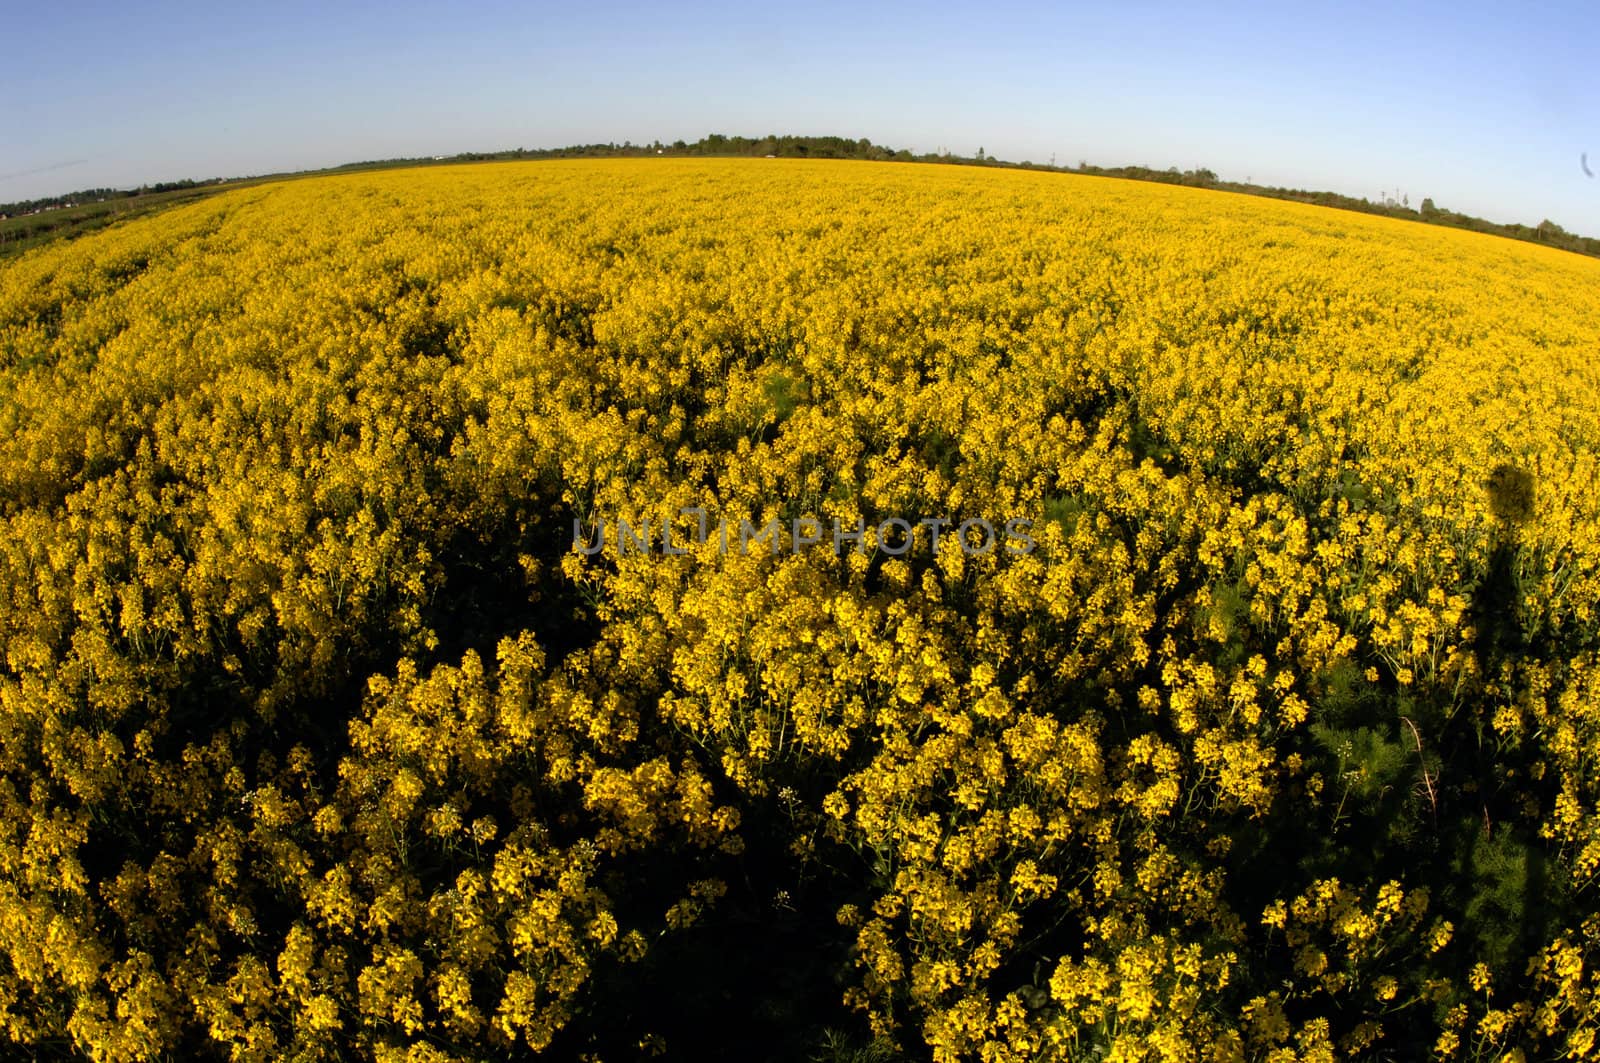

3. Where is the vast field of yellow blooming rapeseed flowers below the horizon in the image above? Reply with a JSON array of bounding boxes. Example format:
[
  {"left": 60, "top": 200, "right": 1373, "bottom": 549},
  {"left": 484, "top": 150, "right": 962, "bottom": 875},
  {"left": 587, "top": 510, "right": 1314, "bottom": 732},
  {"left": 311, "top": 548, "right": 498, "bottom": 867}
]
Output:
[{"left": 0, "top": 158, "right": 1600, "bottom": 1063}]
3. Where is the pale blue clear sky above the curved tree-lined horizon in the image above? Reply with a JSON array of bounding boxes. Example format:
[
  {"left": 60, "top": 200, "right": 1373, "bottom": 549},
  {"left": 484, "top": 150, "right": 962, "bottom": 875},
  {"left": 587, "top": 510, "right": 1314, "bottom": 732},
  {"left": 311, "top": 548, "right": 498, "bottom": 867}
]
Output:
[{"left": 0, "top": 0, "right": 1600, "bottom": 235}]
